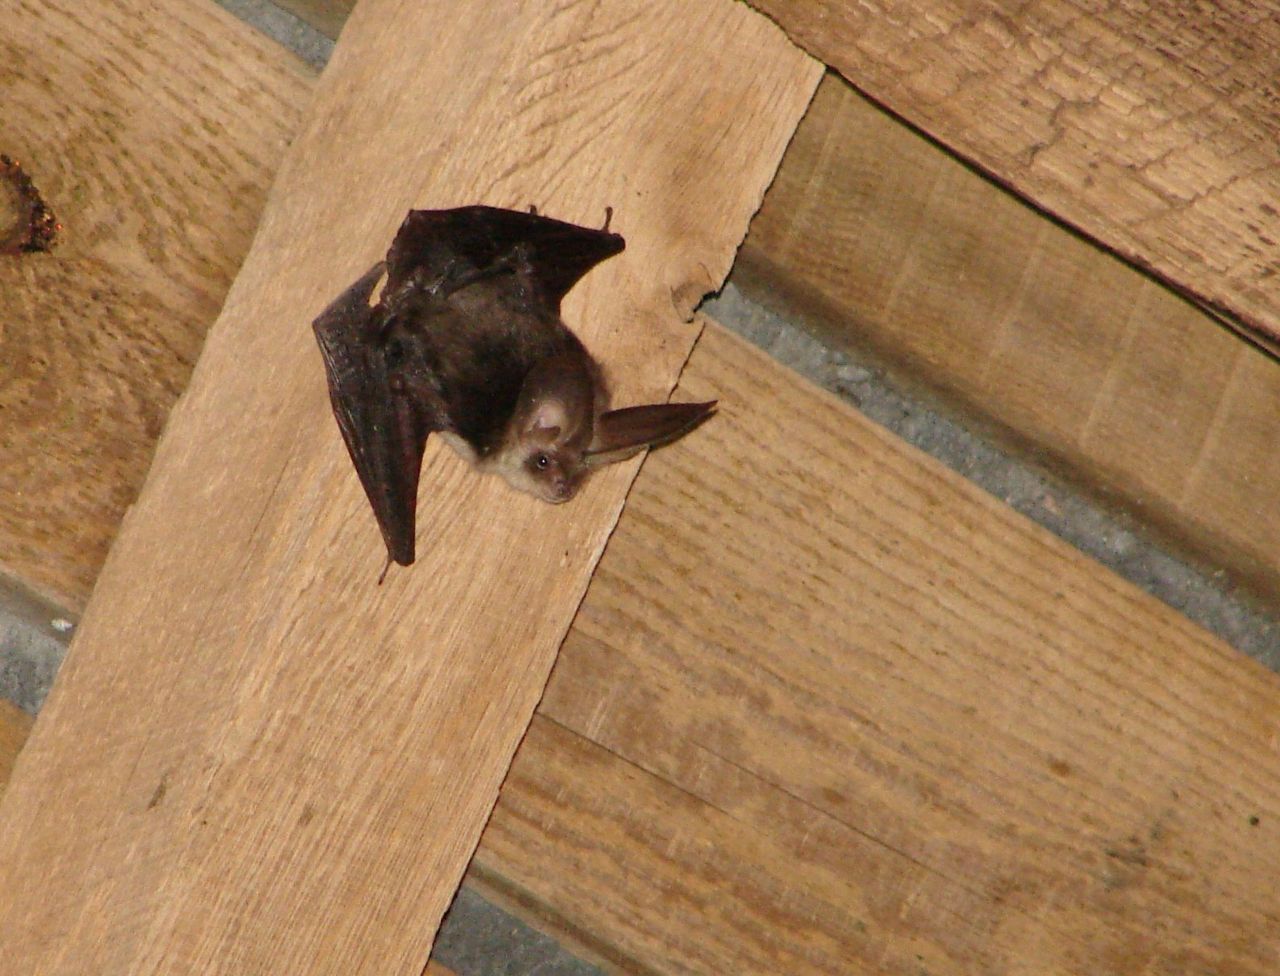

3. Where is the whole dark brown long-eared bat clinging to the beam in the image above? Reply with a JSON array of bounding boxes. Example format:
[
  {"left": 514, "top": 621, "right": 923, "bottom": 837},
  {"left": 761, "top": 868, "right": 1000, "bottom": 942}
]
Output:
[{"left": 312, "top": 206, "right": 716, "bottom": 566}]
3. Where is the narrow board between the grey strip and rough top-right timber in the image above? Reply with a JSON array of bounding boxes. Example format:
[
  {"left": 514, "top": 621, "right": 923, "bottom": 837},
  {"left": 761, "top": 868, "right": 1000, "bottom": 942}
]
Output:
[{"left": 735, "top": 78, "right": 1280, "bottom": 603}]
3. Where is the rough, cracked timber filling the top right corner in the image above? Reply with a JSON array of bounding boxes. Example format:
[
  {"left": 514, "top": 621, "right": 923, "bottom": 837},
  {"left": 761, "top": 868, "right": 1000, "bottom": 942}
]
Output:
[{"left": 753, "top": 0, "right": 1280, "bottom": 345}]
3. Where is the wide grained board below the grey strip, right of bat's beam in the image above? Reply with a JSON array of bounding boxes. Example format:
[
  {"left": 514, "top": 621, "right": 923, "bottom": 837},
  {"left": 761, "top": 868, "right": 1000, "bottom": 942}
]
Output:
[{"left": 477, "top": 327, "right": 1280, "bottom": 976}]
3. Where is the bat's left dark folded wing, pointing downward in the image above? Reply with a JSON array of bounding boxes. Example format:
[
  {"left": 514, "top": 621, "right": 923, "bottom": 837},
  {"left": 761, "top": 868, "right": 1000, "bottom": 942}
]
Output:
[{"left": 311, "top": 264, "right": 435, "bottom": 566}]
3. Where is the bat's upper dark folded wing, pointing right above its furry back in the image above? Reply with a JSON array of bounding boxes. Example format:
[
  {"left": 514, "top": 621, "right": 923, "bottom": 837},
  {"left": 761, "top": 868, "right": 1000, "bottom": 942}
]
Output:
[{"left": 387, "top": 206, "right": 626, "bottom": 313}]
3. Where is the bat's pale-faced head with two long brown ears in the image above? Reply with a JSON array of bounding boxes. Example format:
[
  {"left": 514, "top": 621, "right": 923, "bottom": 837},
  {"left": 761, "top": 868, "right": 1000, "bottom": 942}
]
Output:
[{"left": 493, "top": 356, "right": 716, "bottom": 505}]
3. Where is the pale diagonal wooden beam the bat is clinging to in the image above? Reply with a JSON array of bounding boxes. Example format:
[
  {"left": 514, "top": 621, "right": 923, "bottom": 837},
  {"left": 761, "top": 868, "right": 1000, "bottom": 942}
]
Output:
[{"left": 0, "top": 7, "right": 820, "bottom": 975}]
